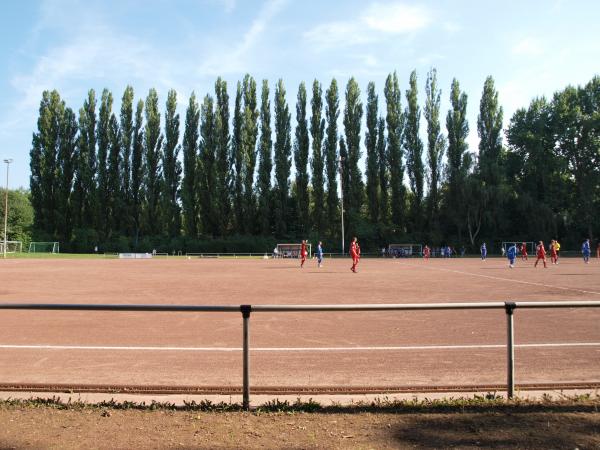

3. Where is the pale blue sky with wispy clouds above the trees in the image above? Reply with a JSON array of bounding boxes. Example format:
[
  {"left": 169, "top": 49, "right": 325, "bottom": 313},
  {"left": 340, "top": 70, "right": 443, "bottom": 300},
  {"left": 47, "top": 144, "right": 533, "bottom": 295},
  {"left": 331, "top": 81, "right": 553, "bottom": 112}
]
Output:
[{"left": 0, "top": 0, "right": 600, "bottom": 187}]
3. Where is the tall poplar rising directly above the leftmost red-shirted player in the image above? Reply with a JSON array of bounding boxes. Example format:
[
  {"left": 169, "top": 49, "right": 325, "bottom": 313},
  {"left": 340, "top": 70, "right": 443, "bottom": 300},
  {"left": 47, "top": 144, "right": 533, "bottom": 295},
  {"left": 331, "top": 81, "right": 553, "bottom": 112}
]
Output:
[{"left": 294, "top": 82, "right": 310, "bottom": 236}]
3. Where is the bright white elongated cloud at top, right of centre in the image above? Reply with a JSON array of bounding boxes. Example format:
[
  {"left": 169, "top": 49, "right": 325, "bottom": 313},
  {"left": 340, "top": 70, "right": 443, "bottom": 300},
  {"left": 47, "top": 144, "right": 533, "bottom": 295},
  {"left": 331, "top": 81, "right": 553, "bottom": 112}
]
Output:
[{"left": 304, "top": 2, "right": 432, "bottom": 49}]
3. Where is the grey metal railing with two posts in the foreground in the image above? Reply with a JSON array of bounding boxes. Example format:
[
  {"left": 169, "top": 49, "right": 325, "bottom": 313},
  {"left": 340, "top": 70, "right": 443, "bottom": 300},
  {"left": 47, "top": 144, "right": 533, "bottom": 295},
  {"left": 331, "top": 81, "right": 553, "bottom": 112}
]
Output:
[{"left": 0, "top": 301, "right": 600, "bottom": 410}]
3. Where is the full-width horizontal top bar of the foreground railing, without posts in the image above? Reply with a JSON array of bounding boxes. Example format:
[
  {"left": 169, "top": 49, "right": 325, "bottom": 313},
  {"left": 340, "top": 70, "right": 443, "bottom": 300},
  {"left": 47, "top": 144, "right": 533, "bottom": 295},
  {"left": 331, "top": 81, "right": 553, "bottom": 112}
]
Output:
[{"left": 0, "top": 301, "right": 600, "bottom": 313}]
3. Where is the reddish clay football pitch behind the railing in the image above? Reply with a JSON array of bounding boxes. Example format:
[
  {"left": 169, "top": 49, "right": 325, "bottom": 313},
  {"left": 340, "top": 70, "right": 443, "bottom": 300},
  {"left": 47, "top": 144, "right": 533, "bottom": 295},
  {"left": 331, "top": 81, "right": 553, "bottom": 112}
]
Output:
[{"left": 0, "top": 258, "right": 600, "bottom": 392}]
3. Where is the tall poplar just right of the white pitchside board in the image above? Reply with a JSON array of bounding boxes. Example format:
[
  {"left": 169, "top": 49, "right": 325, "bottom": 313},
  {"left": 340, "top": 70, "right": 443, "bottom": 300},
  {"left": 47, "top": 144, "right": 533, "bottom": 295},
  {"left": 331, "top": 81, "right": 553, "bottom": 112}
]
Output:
[{"left": 161, "top": 90, "right": 181, "bottom": 237}]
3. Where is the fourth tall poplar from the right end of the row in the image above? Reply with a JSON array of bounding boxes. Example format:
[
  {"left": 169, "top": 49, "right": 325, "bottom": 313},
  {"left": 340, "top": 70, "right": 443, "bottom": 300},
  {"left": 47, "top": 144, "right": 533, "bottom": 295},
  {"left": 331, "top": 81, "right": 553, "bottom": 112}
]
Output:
[{"left": 404, "top": 70, "right": 425, "bottom": 230}]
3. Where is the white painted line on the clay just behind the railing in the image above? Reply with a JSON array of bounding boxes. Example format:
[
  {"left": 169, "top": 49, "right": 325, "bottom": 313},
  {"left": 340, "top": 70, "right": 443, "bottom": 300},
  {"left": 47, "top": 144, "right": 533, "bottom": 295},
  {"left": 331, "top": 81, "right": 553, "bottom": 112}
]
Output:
[{"left": 0, "top": 342, "right": 600, "bottom": 352}]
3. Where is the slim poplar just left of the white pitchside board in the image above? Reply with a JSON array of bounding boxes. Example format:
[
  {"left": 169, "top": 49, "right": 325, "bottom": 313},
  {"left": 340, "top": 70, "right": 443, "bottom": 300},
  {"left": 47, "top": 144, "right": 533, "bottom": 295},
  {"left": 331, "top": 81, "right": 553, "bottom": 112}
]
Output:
[{"left": 96, "top": 89, "right": 113, "bottom": 238}]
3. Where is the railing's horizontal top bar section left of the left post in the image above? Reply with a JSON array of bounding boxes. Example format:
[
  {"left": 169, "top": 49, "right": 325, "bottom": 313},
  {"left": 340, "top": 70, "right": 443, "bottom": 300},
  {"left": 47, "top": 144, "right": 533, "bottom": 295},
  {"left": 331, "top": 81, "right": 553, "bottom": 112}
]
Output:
[{"left": 0, "top": 303, "right": 241, "bottom": 313}]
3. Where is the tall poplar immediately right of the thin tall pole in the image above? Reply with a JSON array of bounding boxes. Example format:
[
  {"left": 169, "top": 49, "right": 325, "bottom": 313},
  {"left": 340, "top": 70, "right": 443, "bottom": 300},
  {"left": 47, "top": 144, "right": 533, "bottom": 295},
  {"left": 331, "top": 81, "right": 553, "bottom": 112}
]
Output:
[{"left": 344, "top": 78, "right": 364, "bottom": 232}]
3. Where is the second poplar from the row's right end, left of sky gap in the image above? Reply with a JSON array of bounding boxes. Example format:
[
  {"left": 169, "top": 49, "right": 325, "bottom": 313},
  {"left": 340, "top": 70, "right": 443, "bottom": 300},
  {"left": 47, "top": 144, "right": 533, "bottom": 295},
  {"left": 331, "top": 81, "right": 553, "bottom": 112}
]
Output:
[{"left": 444, "top": 79, "right": 471, "bottom": 242}]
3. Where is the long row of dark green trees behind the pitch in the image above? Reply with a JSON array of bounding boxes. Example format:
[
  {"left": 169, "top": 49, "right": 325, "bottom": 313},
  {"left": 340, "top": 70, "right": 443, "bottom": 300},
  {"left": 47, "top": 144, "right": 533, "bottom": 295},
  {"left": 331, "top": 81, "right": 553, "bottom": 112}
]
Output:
[{"left": 30, "top": 69, "right": 600, "bottom": 251}]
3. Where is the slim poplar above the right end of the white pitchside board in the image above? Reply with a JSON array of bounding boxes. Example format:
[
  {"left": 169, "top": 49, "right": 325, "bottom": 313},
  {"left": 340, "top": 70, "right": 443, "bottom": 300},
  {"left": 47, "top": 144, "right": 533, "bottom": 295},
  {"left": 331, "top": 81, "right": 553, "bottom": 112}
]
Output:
[{"left": 144, "top": 88, "right": 163, "bottom": 236}]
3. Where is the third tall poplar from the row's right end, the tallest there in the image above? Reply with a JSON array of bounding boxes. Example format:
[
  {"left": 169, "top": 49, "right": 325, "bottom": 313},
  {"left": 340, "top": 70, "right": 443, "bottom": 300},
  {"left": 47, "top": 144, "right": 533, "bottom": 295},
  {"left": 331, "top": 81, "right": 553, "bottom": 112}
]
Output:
[{"left": 424, "top": 69, "right": 446, "bottom": 233}]
